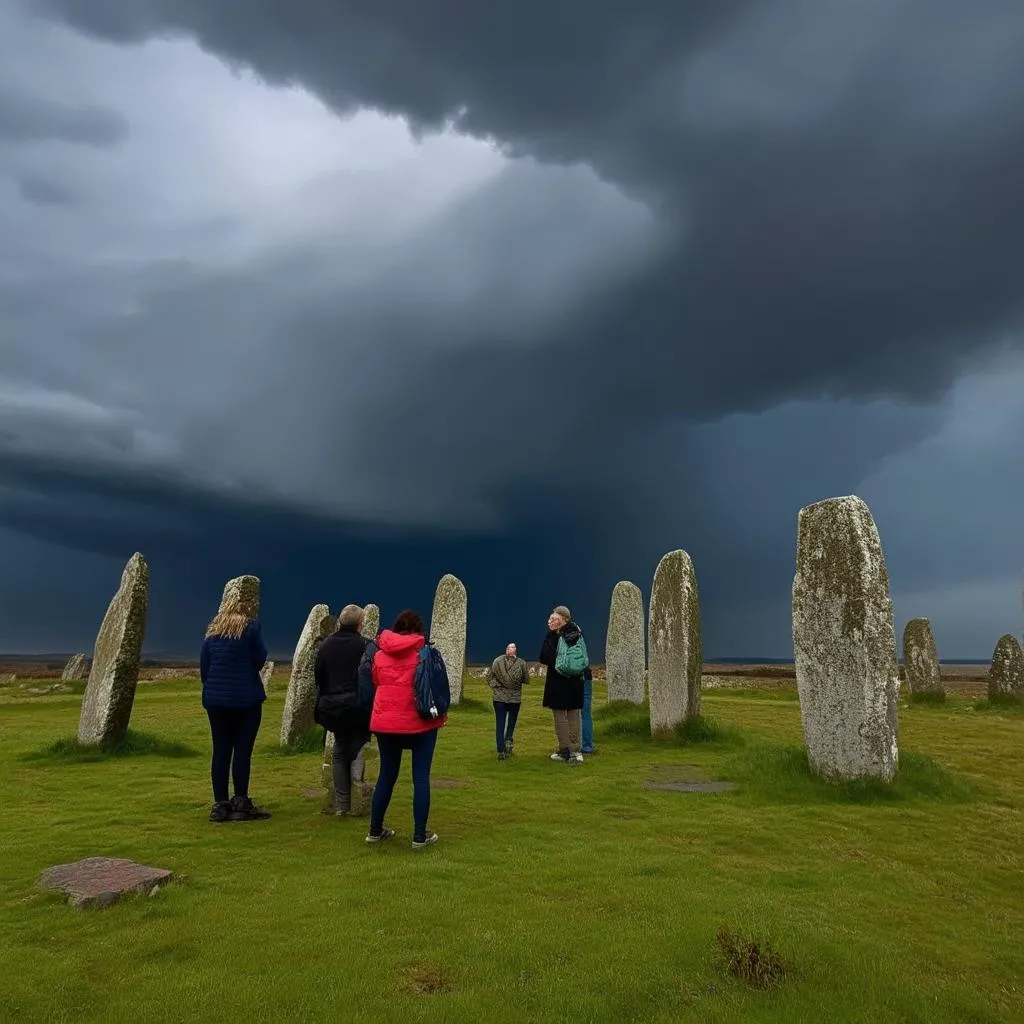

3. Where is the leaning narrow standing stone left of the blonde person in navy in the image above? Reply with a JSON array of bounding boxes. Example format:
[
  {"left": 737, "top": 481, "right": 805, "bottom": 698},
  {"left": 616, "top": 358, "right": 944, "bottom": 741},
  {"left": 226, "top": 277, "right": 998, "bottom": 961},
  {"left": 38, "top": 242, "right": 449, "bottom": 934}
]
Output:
[{"left": 78, "top": 551, "right": 150, "bottom": 744}]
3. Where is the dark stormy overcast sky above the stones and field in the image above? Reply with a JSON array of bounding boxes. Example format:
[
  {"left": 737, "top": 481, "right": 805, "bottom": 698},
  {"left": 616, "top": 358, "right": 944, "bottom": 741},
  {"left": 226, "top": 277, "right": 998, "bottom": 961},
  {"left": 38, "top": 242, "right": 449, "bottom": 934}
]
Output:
[{"left": 0, "top": 0, "right": 1024, "bottom": 659}]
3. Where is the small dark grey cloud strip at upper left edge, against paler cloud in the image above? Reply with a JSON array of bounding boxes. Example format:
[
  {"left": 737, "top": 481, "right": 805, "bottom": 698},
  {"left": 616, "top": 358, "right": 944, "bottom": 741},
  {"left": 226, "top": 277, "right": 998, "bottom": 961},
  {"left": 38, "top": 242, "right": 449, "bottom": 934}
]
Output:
[{"left": 0, "top": 83, "right": 128, "bottom": 148}]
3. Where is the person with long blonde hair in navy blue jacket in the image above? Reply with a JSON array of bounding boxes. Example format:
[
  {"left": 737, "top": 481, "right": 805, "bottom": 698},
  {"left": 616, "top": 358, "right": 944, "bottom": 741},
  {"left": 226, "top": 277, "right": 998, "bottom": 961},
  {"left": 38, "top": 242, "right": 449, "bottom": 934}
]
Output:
[{"left": 199, "top": 602, "right": 270, "bottom": 821}]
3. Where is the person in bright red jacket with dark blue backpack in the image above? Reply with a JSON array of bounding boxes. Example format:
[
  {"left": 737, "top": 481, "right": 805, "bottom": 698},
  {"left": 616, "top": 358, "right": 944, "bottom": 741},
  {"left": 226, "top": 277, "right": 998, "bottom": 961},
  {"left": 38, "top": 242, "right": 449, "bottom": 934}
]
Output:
[{"left": 367, "top": 611, "right": 447, "bottom": 850}]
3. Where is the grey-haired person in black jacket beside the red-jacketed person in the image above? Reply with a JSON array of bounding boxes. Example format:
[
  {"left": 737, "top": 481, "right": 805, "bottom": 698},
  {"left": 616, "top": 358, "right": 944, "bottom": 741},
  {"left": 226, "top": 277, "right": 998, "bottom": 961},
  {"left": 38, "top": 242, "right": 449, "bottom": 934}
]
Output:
[{"left": 313, "top": 604, "right": 372, "bottom": 815}]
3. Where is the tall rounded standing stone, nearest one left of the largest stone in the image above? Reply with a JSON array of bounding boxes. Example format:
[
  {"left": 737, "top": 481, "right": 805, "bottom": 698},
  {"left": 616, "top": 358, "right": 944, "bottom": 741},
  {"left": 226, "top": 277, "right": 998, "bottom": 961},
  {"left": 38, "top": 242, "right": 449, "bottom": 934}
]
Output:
[{"left": 647, "top": 550, "right": 703, "bottom": 733}]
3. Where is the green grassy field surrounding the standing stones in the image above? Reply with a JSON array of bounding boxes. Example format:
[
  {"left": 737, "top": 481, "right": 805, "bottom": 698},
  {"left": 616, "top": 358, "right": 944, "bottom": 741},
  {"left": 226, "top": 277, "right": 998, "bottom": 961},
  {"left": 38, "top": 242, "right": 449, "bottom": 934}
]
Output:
[{"left": 0, "top": 680, "right": 1024, "bottom": 1024}]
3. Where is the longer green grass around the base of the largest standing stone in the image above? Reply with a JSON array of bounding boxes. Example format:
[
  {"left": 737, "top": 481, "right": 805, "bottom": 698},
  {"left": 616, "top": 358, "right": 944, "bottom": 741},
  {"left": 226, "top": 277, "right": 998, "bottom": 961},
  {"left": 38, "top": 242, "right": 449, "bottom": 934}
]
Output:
[{"left": 728, "top": 741, "right": 977, "bottom": 804}]
